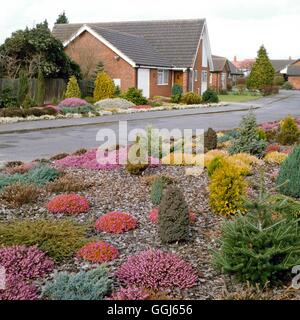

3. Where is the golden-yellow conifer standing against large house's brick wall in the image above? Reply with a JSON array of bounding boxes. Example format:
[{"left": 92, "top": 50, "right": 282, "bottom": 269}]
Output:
[{"left": 94, "top": 71, "right": 115, "bottom": 101}]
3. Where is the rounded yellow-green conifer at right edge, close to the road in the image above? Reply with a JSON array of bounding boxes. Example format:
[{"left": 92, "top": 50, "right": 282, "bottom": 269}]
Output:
[{"left": 277, "top": 116, "right": 300, "bottom": 145}]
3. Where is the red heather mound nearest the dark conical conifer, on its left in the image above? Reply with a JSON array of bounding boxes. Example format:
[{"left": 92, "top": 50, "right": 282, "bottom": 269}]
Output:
[{"left": 95, "top": 212, "right": 138, "bottom": 234}]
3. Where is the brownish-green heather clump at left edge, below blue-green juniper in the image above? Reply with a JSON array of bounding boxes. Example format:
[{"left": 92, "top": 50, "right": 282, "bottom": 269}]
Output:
[{"left": 1, "top": 183, "right": 40, "bottom": 207}]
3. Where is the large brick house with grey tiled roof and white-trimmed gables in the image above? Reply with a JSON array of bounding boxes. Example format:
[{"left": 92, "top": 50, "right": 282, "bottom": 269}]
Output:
[{"left": 53, "top": 19, "right": 213, "bottom": 98}]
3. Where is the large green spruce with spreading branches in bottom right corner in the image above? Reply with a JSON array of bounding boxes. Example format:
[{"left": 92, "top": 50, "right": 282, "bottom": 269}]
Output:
[{"left": 214, "top": 193, "right": 300, "bottom": 286}]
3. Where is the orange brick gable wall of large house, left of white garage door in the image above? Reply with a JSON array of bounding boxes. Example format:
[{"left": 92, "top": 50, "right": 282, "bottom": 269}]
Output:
[{"left": 65, "top": 32, "right": 136, "bottom": 91}]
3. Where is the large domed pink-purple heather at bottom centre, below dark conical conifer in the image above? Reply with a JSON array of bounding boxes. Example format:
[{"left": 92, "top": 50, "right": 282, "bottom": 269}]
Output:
[{"left": 116, "top": 250, "right": 197, "bottom": 290}]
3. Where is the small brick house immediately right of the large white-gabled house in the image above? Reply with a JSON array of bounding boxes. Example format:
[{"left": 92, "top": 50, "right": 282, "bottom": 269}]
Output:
[{"left": 210, "top": 55, "right": 243, "bottom": 92}]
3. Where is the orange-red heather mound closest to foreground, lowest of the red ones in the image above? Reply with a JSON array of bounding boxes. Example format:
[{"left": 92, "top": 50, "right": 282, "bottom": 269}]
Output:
[{"left": 76, "top": 241, "right": 119, "bottom": 263}]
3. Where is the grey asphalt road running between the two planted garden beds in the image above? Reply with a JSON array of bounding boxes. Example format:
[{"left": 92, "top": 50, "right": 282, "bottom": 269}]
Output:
[{"left": 0, "top": 91, "right": 300, "bottom": 161}]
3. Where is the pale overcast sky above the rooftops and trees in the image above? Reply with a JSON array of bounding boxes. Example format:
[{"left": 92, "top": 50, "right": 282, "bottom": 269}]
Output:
[{"left": 0, "top": 0, "right": 300, "bottom": 59}]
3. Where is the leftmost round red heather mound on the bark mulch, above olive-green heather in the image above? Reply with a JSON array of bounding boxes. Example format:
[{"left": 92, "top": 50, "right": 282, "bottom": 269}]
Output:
[{"left": 47, "top": 194, "right": 90, "bottom": 215}]
